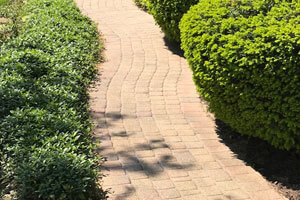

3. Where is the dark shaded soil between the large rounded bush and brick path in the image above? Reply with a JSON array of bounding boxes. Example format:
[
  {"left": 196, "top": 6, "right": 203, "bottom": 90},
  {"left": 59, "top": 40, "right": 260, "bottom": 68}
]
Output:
[{"left": 216, "top": 120, "right": 300, "bottom": 200}]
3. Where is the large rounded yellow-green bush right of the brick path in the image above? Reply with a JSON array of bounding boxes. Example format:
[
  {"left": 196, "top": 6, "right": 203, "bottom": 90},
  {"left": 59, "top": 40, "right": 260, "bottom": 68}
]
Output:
[{"left": 180, "top": 0, "right": 300, "bottom": 149}]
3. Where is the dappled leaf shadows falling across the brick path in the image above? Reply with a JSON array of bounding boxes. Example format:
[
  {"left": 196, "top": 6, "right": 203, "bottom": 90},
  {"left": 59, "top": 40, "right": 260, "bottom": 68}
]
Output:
[{"left": 93, "top": 112, "right": 195, "bottom": 199}]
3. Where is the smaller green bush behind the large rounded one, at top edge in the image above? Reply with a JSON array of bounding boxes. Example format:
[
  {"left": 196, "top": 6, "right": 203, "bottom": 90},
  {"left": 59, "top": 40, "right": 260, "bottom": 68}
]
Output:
[{"left": 148, "top": 0, "right": 199, "bottom": 42}]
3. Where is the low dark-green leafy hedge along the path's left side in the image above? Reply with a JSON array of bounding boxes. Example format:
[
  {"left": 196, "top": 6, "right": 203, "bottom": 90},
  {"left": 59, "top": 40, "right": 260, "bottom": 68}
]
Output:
[{"left": 0, "top": 0, "right": 104, "bottom": 200}]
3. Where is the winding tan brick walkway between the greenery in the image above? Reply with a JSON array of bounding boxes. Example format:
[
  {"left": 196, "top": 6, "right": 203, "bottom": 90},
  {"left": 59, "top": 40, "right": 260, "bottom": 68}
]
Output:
[{"left": 76, "top": 0, "right": 284, "bottom": 200}]
